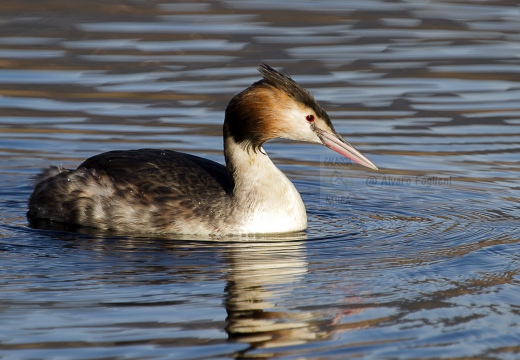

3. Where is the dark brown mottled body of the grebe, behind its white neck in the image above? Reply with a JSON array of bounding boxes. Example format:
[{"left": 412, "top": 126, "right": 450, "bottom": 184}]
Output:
[{"left": 27, "top": 149, "right": 233, "bottom": 233}]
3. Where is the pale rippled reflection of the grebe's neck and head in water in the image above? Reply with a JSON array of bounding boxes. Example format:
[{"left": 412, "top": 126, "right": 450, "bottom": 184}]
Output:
[{"left": 225, "top": 235, "right": 364, "bottom": 358}]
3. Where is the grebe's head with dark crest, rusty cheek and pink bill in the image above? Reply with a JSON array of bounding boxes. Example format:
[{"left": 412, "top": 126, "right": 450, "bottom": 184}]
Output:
[{"left": 224, "top": 64, "right": 377, "bottom": 170}]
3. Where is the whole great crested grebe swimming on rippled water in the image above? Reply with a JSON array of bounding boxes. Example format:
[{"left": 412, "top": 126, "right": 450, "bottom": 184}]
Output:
[{"left": 27, "top": 64, "right": 377, "bottom": 235}]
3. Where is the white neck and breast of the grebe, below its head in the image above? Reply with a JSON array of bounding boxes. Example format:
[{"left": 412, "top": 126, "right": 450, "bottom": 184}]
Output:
[{"left": 224, "top": 136, "right": 307, "bottom": 233}]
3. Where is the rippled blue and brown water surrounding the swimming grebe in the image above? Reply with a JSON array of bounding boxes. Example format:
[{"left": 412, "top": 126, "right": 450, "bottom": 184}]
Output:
[{"left": 0, "top": 0, "right": 520, "bottom": 359}]
